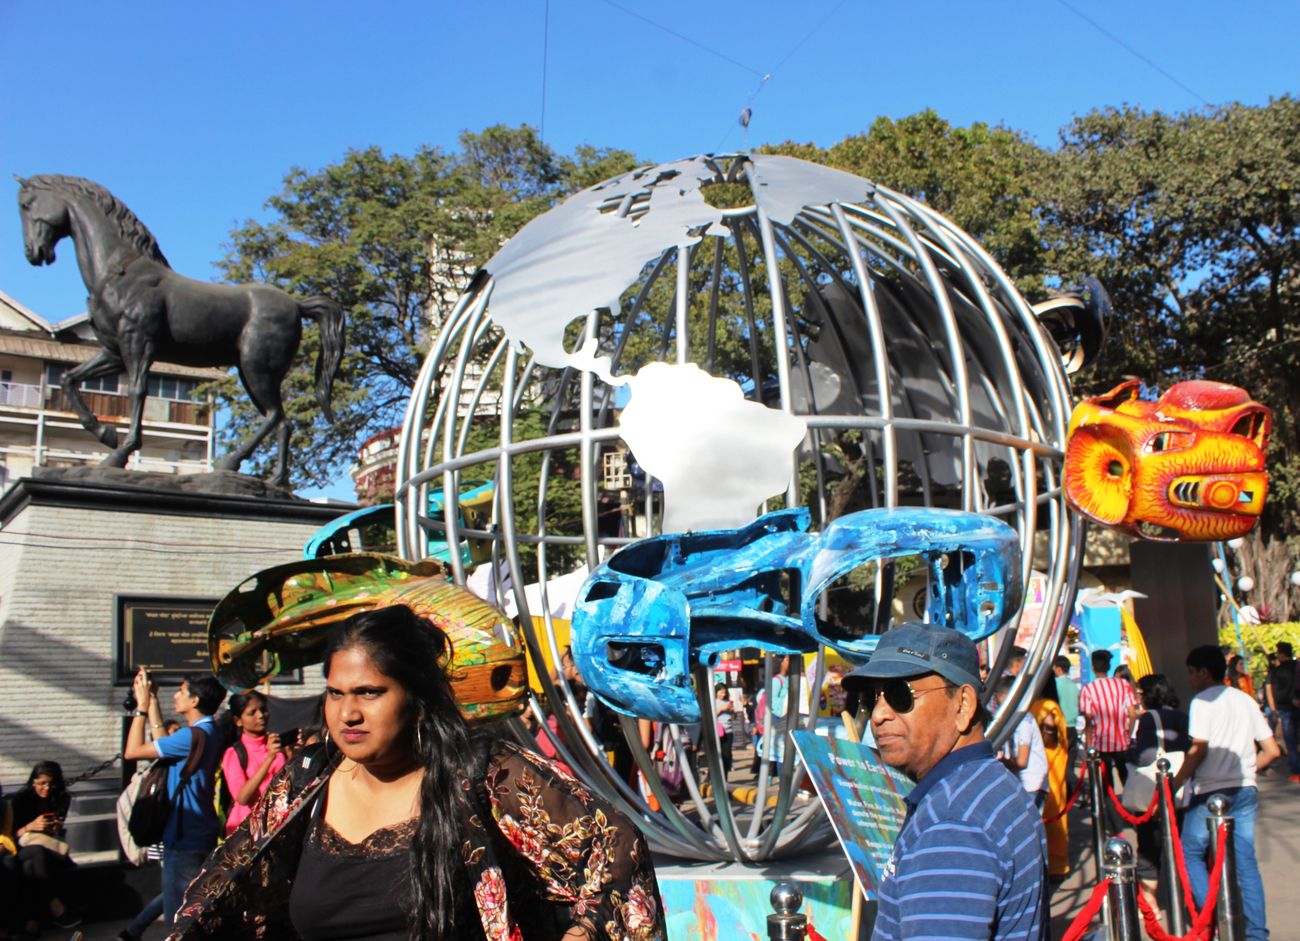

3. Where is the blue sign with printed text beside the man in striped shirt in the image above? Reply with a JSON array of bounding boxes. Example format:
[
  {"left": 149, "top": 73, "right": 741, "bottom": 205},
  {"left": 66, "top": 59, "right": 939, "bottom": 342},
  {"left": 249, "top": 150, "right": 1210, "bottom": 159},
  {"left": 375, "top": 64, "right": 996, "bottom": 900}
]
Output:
[{"left": 790, "top": 732, "right": 913, "bottom": 898}]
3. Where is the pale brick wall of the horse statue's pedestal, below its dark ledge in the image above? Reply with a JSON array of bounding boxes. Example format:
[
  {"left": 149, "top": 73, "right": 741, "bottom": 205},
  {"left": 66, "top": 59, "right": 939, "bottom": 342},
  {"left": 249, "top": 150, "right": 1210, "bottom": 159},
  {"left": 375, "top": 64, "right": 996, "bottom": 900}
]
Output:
[{"left": 0, "top": 502, "right": 330, "bottom": 790}]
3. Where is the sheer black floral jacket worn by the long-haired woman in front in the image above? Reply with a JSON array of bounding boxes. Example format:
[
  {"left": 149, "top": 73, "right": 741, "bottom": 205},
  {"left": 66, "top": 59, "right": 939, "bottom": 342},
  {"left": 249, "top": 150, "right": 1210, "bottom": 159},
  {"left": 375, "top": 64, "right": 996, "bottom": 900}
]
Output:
[{"left": 169, "top": 742, "right": 666, "bottom": 941}]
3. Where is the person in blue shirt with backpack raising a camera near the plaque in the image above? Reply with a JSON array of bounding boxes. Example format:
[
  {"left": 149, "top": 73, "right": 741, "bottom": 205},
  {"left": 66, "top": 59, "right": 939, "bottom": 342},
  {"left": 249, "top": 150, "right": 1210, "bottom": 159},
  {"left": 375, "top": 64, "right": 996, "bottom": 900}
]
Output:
[{"left": 122, "top": 667, "right": 226, "bottom": 927}]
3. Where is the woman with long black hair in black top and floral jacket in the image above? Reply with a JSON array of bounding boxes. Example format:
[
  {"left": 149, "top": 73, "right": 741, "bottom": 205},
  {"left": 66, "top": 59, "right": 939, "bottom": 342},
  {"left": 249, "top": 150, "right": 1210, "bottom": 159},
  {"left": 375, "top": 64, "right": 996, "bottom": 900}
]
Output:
[{"left": 172, "top": 606, "right": 664, "bottom": 941}]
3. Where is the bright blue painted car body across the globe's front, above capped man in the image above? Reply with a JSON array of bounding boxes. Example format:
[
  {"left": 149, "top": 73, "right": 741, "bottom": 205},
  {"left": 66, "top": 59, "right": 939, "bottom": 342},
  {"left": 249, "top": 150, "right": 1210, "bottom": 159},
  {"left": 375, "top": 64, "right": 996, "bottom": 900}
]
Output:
[{"left": 572, "top": 507, "right": 1023, "bottom": 723}]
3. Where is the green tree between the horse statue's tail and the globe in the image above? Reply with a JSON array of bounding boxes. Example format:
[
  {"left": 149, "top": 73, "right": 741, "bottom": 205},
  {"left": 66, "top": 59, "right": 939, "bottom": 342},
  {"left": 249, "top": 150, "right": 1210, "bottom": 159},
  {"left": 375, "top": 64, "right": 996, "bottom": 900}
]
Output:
[{"left": 216, "top": 126, "right": 634, "bottom": 485}]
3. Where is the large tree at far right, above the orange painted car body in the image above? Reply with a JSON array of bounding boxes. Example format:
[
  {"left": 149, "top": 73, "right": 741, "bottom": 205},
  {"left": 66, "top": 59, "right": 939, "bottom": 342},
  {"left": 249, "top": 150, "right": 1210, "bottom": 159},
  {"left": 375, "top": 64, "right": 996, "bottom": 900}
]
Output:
[{"left": 1043, "top": 96, "right": 1300, "bottom": 616}]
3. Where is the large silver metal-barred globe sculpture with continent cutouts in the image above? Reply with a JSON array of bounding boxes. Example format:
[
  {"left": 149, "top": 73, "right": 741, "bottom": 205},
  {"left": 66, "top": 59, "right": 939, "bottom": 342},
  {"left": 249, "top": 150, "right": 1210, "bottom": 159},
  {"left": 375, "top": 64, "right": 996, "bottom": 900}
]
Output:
[{"left": 397, "top": 155, "right": 1082, "bottom": 862}]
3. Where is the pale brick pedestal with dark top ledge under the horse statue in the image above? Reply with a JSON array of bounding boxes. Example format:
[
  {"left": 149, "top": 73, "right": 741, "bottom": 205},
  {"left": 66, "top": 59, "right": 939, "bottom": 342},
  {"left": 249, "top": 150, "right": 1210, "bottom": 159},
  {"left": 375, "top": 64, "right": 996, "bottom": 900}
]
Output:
[{"left": 0, "top": 472, "right": 352, "bottom": 790}]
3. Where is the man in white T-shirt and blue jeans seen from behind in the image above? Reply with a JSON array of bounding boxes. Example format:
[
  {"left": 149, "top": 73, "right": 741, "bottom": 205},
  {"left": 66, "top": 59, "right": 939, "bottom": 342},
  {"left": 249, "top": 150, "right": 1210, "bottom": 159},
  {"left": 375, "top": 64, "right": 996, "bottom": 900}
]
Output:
[{"left": 1173, "top": 646, "right": 1282, "bottom": 941}]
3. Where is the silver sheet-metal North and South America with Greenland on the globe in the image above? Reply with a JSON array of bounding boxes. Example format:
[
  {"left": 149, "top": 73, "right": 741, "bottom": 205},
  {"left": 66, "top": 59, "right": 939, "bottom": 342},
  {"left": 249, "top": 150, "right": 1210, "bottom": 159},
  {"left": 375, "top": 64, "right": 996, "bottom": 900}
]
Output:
[{"left": 485, "top": 156, "right": 872, "bottom": 532}]
